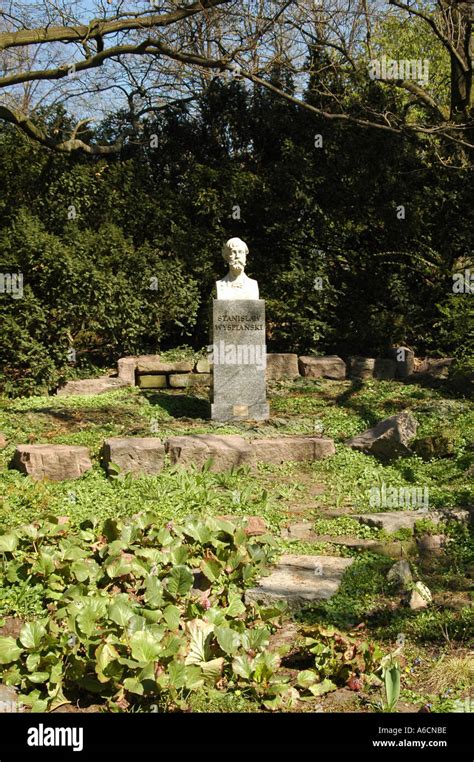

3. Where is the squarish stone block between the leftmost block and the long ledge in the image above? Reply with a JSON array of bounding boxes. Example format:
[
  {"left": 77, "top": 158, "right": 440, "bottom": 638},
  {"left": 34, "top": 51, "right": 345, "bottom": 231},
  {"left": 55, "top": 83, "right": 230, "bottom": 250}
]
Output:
[{"left": 102, "top": 437, "right": 165, "bottom": 476}]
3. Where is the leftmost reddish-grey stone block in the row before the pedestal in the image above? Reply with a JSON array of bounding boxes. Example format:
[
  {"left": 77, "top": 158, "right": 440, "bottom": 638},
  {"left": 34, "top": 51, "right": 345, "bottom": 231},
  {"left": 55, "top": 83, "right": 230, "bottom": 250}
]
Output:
[{"left": 10, "top": 444, "right": 92, "bottom": 482}]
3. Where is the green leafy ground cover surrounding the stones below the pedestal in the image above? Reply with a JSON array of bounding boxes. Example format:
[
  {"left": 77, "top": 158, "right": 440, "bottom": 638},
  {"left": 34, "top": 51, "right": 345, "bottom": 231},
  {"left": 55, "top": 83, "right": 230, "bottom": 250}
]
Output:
[{"left": 0, "top": 379, "right": 474, "bottom": 711}]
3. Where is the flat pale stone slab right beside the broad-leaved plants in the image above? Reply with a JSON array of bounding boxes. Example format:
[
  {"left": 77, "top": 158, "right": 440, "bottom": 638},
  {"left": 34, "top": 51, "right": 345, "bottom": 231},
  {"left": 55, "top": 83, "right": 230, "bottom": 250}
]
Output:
[{"left": 245, "top": 554, "right": 354, "bottom": 610}]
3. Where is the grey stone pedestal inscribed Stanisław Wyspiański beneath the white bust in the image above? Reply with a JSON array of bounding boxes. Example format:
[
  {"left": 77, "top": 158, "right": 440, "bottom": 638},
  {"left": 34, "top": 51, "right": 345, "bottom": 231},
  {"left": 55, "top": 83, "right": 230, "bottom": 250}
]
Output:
[{"left": 210, "top": 299, "right": 270, "bottom": 421}]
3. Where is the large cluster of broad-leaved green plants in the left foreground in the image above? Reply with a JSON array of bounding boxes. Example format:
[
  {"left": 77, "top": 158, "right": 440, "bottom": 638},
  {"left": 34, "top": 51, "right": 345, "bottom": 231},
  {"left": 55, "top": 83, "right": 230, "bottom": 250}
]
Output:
[{"left": 0, "top": 513, "right": 293, "bottom": 711}]
